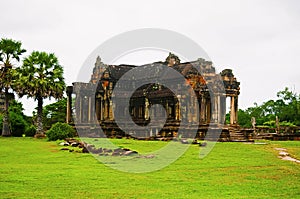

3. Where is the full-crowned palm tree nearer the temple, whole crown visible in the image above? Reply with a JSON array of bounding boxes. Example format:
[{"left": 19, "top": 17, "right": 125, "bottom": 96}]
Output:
[{"left": 17, "top": 51, "right": 66, "bottom": 135}]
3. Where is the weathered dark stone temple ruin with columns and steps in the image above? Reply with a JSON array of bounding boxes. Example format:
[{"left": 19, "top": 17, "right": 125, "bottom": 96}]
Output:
[{"left": 66, "top": 53, "right": 247, "bottom": 141}]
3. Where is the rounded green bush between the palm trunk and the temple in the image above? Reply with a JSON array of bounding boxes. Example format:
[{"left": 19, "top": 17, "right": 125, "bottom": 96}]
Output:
[{"left": 46, "top": 122, "right": 75, "bottom": 141}]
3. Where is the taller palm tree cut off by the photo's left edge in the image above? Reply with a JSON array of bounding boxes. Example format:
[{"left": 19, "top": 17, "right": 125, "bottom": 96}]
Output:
[{"left": 0, "top": 39, "right": 26, "bottom": 136}]
